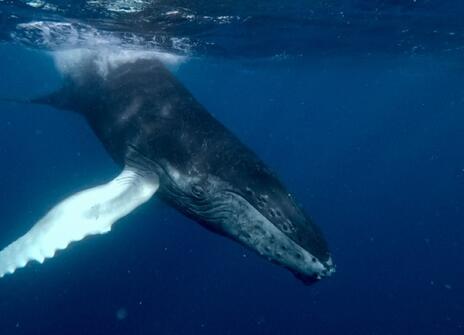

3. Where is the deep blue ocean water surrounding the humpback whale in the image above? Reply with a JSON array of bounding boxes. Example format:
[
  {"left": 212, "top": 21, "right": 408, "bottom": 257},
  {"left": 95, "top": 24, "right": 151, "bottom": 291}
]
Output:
[{"left": 0, "top": 1, "right": 464, "bottom": 335}]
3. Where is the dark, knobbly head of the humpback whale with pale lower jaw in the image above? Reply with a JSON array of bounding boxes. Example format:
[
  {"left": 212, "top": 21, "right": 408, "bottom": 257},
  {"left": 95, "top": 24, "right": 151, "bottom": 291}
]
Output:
[{"left": 158, "top": 148, "right": 334, "bottom": 285}]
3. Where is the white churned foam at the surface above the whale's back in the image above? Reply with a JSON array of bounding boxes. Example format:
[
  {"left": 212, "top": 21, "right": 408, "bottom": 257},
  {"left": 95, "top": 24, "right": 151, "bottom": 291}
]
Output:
[{"left": 14, "top": 21, "right": 189, "bottom": 76}]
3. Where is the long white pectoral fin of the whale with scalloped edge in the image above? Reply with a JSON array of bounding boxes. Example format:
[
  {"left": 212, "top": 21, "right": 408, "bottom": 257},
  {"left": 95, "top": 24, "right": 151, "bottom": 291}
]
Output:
[{"left": 0, "top": 167, "right": 159, "bottom": 278}]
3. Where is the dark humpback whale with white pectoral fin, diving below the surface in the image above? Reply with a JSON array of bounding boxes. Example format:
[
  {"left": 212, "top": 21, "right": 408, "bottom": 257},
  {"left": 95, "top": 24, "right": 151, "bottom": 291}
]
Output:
[{"left": 0, "top": 58, "right": 334, "bottom": 284}]
